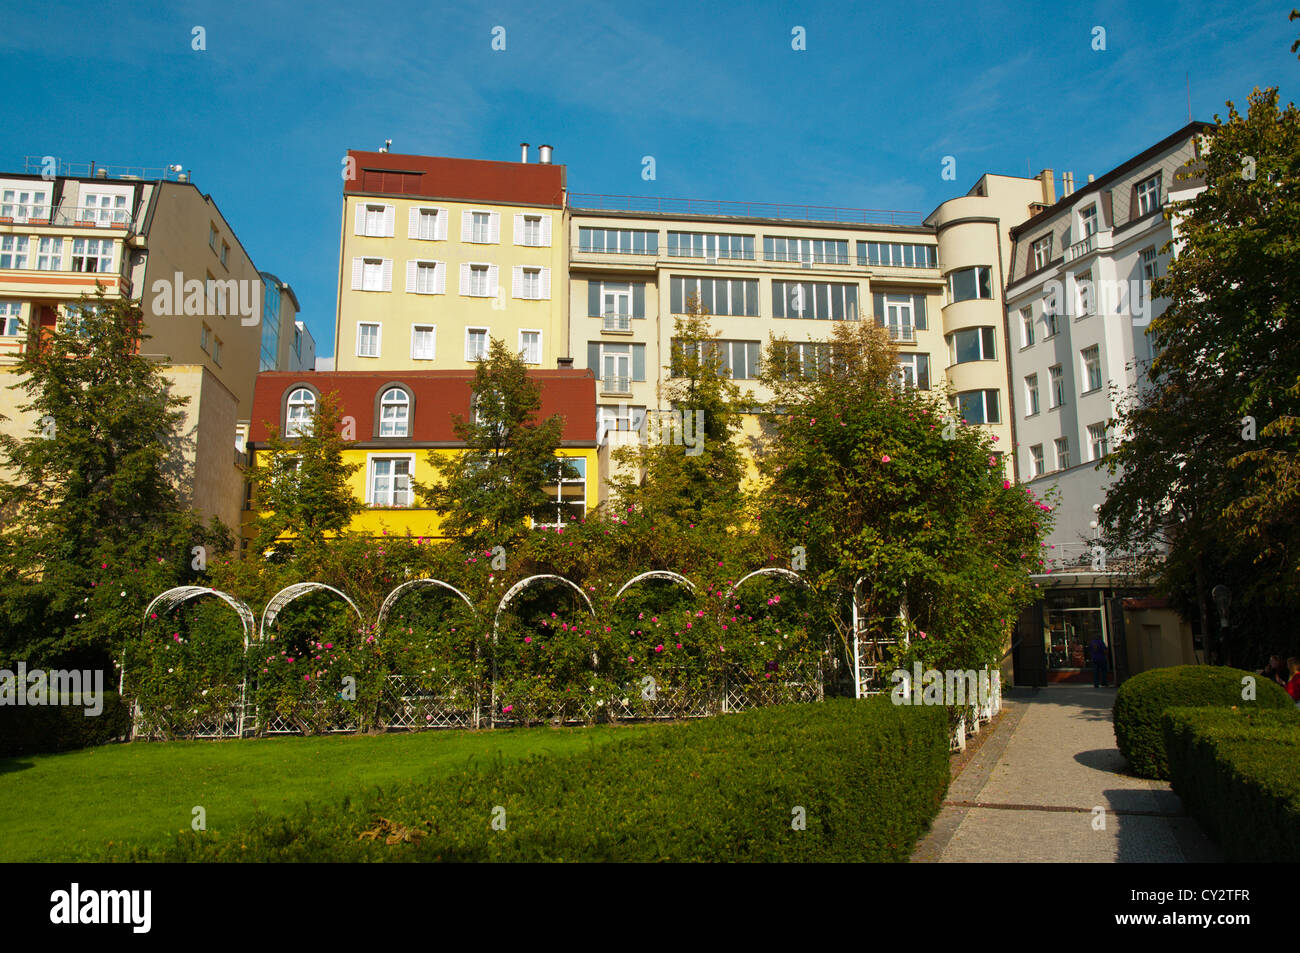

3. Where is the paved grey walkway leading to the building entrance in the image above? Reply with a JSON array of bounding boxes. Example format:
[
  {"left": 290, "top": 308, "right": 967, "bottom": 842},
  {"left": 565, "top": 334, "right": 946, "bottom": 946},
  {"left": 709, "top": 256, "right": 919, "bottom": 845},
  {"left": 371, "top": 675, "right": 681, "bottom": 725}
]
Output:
[{"left": 913, "top": 685, "right": 1222, "bottom": 863}]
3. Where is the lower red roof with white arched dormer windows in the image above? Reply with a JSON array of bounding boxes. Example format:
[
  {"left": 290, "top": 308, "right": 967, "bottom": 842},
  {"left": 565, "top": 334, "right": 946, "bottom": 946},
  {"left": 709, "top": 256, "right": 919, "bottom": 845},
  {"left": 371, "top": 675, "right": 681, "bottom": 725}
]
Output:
[{"left": 248, "top": 369, "right": 595, "bottom": 447}]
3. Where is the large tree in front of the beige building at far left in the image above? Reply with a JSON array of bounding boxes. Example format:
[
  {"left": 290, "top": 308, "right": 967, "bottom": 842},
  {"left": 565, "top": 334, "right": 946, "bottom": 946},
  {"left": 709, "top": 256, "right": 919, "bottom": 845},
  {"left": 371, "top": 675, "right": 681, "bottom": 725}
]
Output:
[{"left": 0, "top": 291, "right": 229, "bottom": 666}]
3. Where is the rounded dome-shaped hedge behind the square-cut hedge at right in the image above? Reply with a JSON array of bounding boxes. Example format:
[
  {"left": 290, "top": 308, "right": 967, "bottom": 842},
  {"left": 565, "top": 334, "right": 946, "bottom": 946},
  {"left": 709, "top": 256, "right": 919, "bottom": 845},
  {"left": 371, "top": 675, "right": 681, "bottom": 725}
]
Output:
[{"left": 1113, "top": 666, "right": 1295, "bottom": 780}]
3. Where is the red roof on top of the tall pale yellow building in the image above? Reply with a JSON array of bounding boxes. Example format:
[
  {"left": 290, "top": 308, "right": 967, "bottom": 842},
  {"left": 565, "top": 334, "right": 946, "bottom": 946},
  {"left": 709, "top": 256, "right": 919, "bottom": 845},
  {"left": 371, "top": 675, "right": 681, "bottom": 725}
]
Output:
[{"left": 343, "top": 150, "right": 564, "bottom": 208}]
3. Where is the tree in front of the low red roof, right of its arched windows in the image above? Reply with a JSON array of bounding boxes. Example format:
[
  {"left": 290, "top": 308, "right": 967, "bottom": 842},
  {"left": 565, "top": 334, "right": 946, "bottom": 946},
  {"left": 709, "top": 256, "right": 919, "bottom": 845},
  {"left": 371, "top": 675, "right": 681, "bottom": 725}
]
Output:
[{"left": 416, "top": 338, "right": 566, "bottom": 546}]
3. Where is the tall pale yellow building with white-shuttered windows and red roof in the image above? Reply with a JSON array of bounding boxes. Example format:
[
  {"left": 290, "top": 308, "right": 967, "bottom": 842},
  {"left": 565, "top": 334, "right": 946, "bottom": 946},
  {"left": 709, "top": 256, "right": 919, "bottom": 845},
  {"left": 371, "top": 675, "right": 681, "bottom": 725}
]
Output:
[{"left": 334, "top": 146, "right": 569, "bottom": 371}]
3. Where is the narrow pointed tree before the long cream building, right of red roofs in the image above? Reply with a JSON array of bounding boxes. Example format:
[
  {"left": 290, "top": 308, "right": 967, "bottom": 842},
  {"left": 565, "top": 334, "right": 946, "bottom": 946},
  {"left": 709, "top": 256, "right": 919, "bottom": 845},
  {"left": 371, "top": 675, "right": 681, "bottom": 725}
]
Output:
[{"left": 610, "top": 295, "right": 751, "bottom": 532}]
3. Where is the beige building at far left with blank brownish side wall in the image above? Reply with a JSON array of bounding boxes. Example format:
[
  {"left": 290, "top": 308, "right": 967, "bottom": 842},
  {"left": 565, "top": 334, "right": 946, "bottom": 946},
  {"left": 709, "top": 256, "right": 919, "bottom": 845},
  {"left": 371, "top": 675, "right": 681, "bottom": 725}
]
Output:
[{"left": 0, "top": 168, "right": 289, "bottom": 528}]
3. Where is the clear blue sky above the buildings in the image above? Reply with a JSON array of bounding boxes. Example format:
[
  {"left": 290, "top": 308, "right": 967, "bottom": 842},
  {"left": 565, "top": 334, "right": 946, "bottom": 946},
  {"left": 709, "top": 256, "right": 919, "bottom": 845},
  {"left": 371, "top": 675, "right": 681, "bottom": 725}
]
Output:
[{"left": 0, "top": 0, "right": 1300, "bottom": 355}]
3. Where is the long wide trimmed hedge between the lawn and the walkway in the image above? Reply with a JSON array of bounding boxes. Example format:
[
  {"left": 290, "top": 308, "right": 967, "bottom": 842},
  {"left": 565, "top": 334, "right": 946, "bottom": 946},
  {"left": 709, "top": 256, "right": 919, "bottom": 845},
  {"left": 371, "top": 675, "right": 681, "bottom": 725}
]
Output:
[{"left": 104, "top": 698, "right": 949, "bottom": 862}]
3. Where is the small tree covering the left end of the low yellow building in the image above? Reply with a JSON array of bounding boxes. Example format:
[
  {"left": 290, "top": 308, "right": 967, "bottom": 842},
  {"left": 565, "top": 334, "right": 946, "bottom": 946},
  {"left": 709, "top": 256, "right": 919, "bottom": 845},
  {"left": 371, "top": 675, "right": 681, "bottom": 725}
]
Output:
[{"left": 248, "top": 394, "right": 365, "bottom": 550}]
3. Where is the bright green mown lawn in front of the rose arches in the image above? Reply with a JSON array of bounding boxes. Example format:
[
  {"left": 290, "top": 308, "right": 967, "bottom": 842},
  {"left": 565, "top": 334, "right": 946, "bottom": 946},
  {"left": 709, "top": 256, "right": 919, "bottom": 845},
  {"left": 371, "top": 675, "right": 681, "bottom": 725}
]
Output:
[{"left": 0, "top": 725, "right": 628, "bottom": 861}]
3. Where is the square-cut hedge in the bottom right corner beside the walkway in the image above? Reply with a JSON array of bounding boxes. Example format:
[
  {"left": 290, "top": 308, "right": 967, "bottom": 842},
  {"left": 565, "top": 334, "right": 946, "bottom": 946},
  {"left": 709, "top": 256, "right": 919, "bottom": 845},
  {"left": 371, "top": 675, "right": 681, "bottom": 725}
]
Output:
[{"left": 1164, "top": 707, "right": 1300, "bottom": 863}]
